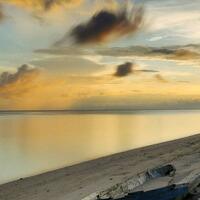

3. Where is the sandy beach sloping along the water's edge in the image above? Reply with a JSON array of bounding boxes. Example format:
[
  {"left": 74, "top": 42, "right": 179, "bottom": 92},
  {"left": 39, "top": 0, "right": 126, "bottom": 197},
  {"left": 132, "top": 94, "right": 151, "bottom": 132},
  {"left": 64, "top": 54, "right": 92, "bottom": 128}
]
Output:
[{"left": 0, "top": 134, "right": 200, "bottom": 200}]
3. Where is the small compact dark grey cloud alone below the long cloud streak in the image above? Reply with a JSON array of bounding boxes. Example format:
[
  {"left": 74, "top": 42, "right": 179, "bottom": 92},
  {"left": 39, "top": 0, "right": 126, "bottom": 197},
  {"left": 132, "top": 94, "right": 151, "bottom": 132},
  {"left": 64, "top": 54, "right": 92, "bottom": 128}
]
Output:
[{"left": 114, "top": 62, "right": 134, "bottom": 77}]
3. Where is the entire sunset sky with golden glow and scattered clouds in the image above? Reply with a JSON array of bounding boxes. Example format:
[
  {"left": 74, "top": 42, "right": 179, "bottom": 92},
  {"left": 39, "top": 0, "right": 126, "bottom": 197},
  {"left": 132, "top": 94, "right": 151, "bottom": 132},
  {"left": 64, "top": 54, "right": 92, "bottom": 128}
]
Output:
[{"left": 0, "top": 0, "right": 200, "bottom": 110}]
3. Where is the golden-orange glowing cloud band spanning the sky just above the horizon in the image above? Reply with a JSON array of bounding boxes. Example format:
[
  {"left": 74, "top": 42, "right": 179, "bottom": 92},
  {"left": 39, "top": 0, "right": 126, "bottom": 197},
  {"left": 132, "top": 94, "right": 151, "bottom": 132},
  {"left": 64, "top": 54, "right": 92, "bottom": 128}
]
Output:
[{"left": 0, "top": 64, "right": 199, "bottom": 110}]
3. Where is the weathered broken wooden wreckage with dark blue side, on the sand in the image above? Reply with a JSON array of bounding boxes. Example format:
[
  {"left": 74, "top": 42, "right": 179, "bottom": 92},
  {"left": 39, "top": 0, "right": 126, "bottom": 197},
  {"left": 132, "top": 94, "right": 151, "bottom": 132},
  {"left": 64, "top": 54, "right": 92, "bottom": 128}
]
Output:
[{"left": 82, "top": 165, "right": 200, "bottom": 200}]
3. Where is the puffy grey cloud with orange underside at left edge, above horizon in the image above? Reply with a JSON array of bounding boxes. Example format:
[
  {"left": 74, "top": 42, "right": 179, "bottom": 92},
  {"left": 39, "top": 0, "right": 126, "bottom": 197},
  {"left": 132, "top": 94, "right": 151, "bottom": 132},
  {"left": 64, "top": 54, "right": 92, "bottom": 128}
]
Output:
[{"left": 0, "top": 64, "right": 39, "bottom": 87}]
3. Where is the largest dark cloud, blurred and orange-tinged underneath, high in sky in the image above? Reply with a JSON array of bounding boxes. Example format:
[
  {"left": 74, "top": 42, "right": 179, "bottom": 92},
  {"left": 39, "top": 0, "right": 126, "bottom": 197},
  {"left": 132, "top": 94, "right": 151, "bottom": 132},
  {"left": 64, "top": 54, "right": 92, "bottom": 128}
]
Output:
[{"left": 55, "top": 6, "right": 144, "bottom": 46}]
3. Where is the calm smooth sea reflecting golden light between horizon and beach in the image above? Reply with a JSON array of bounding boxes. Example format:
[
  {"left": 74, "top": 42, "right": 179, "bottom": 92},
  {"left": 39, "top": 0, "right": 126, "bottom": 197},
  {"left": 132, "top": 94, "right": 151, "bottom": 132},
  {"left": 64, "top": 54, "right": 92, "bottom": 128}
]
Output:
[{"left": 0, "top": 111, "right": 200, "bottom": 183}]
